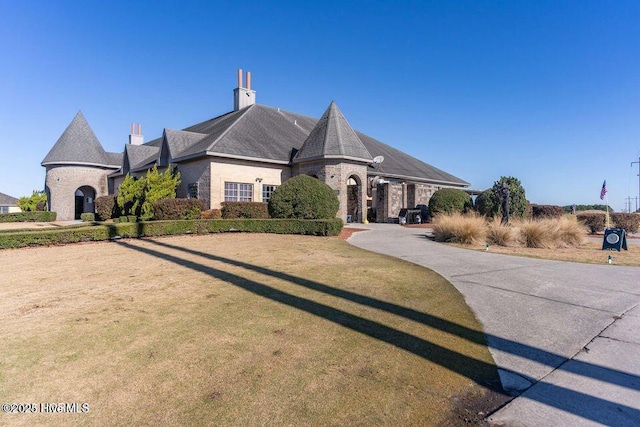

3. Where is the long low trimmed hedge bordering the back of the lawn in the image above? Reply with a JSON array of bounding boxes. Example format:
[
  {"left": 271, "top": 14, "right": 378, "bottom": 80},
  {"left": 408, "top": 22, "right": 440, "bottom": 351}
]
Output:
[{"left": 0, "top": 218, "right": 342, "bottom": 249}]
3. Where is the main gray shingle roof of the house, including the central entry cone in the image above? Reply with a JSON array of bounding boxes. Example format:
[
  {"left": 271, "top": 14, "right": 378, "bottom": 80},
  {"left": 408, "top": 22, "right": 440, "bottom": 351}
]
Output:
[{"left": 104, "top": 103, "right": 469, "bottom": 186}]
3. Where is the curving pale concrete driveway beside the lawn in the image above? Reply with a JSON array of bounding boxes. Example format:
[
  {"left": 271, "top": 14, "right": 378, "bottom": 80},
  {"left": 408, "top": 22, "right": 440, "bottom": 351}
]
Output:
[{"left": 349, "top": 224, "right": 640, "bottom": 426}]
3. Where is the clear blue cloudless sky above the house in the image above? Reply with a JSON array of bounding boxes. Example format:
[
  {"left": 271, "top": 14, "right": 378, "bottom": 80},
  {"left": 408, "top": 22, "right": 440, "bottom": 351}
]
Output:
[{"left": 0, "top": 0, "right": 640, "bottom": 210}]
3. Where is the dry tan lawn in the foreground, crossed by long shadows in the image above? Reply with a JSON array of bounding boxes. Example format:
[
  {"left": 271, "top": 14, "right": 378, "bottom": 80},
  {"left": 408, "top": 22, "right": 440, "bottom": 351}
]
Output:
[{"left": 0, "top": 234, "right": 497, "bottom": 426}]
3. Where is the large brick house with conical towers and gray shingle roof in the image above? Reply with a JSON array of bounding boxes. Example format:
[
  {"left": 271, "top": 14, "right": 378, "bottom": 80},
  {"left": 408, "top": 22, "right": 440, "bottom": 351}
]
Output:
[{"left": 42, "top": 70, "right": 469, "bottom": 222}]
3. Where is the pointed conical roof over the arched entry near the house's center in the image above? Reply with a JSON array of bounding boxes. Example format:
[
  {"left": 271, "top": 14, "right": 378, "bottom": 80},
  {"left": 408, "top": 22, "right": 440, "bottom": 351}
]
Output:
[{"left": 293, "top": 101, "right": 373, "bottom": 163}]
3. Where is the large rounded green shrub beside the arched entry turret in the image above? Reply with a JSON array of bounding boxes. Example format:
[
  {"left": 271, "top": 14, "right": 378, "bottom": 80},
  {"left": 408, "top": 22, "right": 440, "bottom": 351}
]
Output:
[{"left": 269, "top": 175, "right": 340, "bottom": 219}]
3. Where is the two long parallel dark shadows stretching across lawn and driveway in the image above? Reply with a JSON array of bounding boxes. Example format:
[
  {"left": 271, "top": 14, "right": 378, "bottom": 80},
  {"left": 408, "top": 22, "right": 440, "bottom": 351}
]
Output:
[{"left": 118, "top": 240, "right": 640, "bottom": 424}]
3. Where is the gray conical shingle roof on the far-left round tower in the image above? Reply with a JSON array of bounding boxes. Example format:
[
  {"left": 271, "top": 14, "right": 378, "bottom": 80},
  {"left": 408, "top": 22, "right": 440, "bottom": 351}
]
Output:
[{"left": 41, "top": 111, "right": 121, "bottom": 168}]
